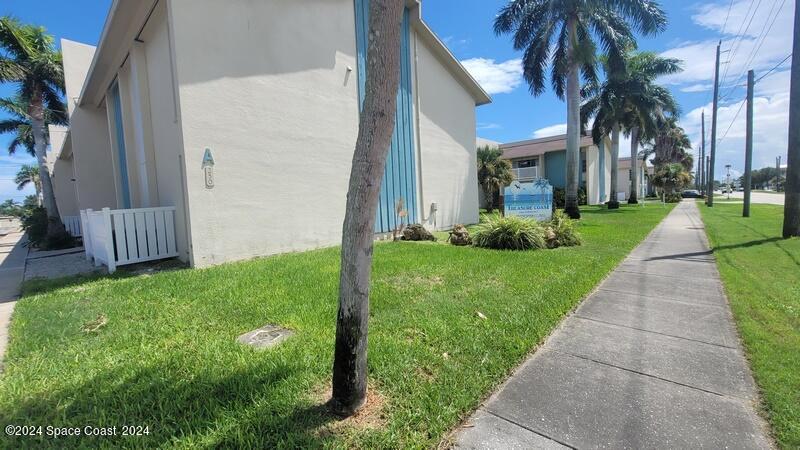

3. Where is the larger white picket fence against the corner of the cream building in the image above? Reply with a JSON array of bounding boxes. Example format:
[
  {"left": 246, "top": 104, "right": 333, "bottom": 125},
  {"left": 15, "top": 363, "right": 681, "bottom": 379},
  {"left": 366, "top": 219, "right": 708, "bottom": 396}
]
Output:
[{"left": 81, "top": 206, "right": 178, "bottom": 273}]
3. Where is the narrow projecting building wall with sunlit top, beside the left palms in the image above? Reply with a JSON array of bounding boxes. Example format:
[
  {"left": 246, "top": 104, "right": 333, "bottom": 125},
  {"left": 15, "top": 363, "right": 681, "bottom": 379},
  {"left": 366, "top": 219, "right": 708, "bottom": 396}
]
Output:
[{"left": 61, "top": 39, "right": 117, "bottom": 209}]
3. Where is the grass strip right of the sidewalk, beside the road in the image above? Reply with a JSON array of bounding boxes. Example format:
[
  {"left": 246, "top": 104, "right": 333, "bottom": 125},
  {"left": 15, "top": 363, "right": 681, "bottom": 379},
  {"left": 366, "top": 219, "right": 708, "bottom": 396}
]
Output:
[{"left": 700, "top": 204, "right": 800, "bottom": 449}]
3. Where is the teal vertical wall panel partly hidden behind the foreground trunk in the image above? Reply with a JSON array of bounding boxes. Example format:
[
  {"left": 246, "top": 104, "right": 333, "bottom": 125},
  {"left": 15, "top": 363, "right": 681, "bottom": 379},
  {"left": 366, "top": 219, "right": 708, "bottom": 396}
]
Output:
[{"left": 355, "top": 0, "right": 417, "bottom": 233}]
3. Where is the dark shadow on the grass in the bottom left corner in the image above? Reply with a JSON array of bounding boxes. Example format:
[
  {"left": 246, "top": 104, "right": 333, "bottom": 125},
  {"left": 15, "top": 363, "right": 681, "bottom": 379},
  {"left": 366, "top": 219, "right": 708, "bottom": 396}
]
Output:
[{"left": 0, "top": 360, "right": 337, "bottom": 448}]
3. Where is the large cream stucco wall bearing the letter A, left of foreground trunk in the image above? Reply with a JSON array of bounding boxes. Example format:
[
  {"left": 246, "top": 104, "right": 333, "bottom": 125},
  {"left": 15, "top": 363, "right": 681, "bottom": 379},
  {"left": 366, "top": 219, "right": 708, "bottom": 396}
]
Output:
[{"left": 170, "top": 0, "right": 360, "bottom": 267}]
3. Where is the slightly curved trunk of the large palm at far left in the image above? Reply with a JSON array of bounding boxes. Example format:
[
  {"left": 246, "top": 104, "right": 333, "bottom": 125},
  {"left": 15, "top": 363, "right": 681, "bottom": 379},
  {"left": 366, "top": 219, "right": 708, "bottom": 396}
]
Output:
[{"left": 29, "top": 93, "right": 66, "bottom": 237}]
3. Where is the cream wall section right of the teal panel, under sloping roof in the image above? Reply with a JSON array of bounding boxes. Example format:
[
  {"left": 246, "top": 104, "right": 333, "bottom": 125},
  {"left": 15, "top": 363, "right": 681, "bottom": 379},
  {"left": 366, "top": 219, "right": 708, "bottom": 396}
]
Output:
[{"left": 414, "top": 27, "right": 478, "bottom": 229}]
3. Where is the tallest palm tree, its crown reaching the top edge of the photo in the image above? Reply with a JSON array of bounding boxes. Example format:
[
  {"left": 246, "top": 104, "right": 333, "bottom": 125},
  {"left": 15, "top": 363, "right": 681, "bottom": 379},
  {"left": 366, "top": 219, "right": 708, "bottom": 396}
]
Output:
[{"left": 494, "top": 0, "right": 667, "bottom": 218}]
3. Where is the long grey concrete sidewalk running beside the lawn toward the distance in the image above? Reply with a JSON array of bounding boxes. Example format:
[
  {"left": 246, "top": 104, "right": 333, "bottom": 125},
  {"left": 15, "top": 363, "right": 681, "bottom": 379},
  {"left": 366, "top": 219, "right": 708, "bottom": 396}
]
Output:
[{"left": 455, "top": 201, "right": 770, "bottom": 449}]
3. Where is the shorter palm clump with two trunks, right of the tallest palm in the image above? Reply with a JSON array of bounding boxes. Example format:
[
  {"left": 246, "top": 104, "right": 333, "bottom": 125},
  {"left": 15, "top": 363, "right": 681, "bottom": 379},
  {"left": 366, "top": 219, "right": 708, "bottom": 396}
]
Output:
[{"left": 581, "top": 50, "right": 682, "bottom": 209}]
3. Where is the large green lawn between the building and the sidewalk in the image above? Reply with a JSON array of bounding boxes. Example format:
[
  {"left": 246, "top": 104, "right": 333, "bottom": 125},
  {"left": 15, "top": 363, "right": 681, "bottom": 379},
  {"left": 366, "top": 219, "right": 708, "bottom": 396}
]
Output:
[{"left": 0, "top": 205, "right": 671, "bottom": 448}]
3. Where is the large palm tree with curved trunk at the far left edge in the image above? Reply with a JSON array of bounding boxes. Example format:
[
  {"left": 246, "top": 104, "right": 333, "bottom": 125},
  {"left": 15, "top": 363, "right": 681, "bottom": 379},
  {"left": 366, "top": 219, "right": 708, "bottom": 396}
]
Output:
[{"left": 0, "top": 17, "right": 66, "bottom": 238}]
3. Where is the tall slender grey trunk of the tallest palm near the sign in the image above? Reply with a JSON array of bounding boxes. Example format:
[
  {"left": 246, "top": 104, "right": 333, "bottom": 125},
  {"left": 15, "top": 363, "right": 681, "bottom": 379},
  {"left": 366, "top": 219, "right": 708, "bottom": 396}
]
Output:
[{"left": 564, "top": 18, "right": 581, "bottom": 219}]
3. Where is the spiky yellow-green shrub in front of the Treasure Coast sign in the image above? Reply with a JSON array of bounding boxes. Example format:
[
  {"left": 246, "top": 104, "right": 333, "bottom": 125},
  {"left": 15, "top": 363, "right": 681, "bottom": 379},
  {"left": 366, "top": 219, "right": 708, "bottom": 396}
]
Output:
[{"left": 472, "top": 216, "right": 547, "bottom": 250}]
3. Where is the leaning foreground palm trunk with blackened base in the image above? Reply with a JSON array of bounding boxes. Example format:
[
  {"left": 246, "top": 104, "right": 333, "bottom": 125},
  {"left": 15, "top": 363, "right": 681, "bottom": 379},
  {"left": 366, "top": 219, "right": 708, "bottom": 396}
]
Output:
[{"left": 330, "top": 0, "right": 404, "bottom": 415}]
